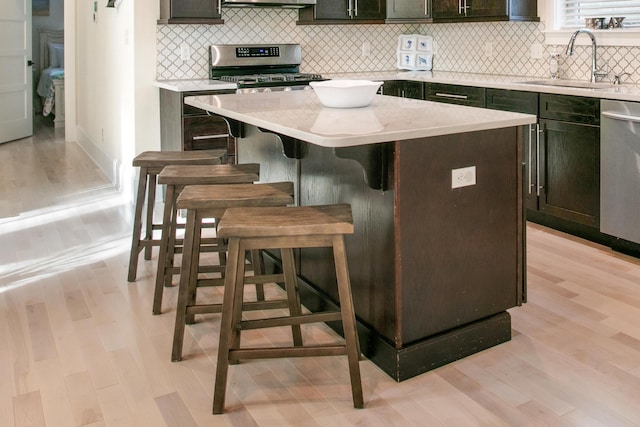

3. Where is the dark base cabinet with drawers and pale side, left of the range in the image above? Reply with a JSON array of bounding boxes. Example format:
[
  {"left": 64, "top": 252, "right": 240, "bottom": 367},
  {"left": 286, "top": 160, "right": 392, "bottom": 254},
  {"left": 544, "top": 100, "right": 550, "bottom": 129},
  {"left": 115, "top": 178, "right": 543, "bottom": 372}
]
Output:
[{"left": 160, "top": 89, "right": 236, "bottom": 164}]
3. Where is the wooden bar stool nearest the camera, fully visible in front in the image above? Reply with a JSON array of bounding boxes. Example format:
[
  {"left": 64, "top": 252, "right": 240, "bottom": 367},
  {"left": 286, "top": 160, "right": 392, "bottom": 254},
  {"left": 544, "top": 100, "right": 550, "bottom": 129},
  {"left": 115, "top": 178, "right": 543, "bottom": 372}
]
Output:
[{"left": 213, "top": 204, "right": 364, "bottom": 414}]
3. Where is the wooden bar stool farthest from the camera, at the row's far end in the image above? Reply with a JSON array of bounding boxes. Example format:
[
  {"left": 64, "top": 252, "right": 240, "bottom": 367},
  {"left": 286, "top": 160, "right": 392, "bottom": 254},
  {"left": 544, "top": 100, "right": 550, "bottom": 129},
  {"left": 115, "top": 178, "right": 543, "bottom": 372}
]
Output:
[{"left": 127, "top": 150, "right": 227, "bottom": 282}]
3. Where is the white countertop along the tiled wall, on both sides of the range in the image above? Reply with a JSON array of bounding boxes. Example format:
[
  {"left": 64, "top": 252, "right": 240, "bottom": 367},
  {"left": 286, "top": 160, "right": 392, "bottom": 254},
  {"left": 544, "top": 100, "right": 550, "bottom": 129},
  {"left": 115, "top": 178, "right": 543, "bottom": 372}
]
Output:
[{"left": 155, "top": 70, "right": 640, "bottom": 102}]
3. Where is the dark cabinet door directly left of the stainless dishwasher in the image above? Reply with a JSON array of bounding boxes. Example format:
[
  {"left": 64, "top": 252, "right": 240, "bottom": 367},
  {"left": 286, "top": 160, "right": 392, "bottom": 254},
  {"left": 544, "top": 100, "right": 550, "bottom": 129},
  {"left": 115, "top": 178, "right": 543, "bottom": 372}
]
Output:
[{"left": 539, "top": 119, "right": 600, "bottom": 227}]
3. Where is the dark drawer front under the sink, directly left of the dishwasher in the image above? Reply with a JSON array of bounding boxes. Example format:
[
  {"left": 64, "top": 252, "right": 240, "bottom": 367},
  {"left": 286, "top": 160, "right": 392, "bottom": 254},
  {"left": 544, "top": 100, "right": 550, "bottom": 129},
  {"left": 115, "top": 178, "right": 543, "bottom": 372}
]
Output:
[{"left": 540, "top": 93, "right": 600, "bottom": 126}]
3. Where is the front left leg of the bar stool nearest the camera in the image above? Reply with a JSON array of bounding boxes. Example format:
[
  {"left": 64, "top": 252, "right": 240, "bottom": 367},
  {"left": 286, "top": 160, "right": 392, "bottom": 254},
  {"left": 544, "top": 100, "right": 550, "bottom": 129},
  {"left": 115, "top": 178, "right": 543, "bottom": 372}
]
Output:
[{"left": 213, "top": 238, "right": 244, "bottom": 414}]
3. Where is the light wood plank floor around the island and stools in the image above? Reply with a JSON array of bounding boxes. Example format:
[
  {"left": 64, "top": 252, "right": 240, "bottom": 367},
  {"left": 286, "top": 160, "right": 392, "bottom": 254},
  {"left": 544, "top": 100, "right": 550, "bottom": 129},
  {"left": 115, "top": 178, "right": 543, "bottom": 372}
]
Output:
[{"left": 0, "top": 115, "right": 640, "bottom": 427}]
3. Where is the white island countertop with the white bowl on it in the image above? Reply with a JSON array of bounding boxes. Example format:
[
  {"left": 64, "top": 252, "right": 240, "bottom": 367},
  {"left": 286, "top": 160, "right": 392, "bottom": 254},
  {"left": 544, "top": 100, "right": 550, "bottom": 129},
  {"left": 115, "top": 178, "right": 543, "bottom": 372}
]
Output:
[{"left": 185, "top": 90, "right": 536, "bottom": 147}]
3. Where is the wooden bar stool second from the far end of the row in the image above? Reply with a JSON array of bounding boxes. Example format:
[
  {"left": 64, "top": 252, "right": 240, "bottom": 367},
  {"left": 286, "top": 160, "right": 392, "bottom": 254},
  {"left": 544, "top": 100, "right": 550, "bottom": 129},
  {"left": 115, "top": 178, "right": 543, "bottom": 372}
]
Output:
[{"left": 153, "top": 163, "right": 264, "bottom": 314}]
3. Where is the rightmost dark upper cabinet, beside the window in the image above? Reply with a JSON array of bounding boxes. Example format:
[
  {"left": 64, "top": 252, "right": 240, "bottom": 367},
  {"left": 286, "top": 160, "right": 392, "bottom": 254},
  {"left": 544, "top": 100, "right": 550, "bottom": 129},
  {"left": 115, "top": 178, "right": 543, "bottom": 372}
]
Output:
[{"left": 432, "top": 0, "right": 539, "bottom": 22}]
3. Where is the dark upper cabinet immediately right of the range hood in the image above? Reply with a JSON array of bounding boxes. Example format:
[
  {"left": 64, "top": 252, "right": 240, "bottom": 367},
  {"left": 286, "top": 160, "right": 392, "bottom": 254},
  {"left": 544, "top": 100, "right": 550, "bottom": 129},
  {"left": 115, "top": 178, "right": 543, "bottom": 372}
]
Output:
[{"left": 298, "top": 0, "right": 386, "bottom": 24}]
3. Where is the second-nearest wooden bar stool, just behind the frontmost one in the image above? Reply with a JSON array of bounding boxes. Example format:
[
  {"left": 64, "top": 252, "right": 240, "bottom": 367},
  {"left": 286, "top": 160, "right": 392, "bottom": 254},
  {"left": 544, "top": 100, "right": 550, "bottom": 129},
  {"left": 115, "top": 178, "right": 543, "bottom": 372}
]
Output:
[{"left": 171, "top": 182, "right": 299, "bottom": 362}]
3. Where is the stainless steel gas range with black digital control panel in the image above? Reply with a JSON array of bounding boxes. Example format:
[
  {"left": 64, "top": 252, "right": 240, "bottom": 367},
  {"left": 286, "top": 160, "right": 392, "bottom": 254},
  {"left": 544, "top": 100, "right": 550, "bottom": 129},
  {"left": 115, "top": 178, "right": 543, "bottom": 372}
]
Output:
[{"left": 209, "top": 44, "right": 324, "bottom": 93}]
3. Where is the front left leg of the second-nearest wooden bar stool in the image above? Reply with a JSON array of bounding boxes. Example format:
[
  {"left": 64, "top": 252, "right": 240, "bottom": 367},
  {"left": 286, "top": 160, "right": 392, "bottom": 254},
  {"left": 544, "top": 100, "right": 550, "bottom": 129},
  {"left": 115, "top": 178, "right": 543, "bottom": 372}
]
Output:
[{"left": 171, "top": 210, "right": 198, "bottom": 362}]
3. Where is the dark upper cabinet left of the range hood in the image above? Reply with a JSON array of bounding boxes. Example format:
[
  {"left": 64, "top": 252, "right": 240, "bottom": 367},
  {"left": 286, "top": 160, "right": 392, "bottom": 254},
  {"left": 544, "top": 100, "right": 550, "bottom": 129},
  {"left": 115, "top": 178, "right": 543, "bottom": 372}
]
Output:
[{"left": 158, "top": 0, "right": 224, "bottom": 24}]
